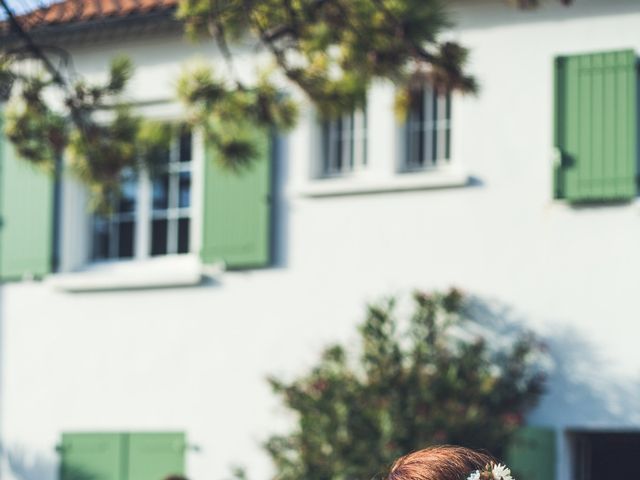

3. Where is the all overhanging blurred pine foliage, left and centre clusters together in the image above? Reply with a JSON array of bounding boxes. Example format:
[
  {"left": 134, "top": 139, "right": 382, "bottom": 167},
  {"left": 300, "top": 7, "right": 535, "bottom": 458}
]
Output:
[{"left": 0, "top": 0, "right": 568, "bottom": 205}]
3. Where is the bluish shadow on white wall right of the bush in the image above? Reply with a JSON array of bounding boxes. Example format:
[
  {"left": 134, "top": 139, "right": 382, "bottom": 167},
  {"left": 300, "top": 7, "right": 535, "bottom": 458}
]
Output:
[{"left": 468, "top": 297, "right": 640, "bottom": 430}]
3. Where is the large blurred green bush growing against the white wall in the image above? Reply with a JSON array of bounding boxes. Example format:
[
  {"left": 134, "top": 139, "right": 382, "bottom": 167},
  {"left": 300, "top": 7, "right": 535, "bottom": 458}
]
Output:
[{"left": 266, "top": 289, "right": 544, "bottom": 480}]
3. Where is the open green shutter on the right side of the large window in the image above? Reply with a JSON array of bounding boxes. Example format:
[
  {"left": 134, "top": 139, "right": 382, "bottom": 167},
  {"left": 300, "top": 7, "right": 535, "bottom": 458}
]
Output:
[{"left": 201, "top": 132, "right": 271, "bottom": 268}]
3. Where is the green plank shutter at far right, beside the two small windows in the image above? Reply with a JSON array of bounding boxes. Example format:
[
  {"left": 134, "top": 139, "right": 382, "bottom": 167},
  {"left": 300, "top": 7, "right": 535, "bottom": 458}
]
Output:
[{"left": 555, "top": 50, "right": 638, "bottom": 202}]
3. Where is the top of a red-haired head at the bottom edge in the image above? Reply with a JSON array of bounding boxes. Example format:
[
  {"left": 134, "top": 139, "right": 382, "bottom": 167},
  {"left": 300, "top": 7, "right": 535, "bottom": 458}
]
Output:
[{"left": 387, "top": 445, "right": 495, "bottom": 480}]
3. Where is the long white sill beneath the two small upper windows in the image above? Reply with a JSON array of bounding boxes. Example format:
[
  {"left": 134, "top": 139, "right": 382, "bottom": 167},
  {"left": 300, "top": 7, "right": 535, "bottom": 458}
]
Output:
[{"left": 296, "top": 169, "right": 469, "bottom": 197}]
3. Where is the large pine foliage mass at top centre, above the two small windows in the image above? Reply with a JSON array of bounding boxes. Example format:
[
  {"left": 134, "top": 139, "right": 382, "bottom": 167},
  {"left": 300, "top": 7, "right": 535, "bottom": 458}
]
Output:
[{"left": 178, "top": 0, "right": 475, "bottom": 109}]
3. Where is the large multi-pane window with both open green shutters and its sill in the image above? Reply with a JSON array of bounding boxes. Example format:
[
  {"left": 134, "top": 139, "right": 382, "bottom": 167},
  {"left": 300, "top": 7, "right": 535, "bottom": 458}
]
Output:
[{"left": 0, "top": 116, "right": 279, "bottom": 282}]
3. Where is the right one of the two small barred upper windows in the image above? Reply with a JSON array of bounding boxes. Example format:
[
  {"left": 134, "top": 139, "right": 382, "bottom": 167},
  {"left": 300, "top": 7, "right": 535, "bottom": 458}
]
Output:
[{"left": 405, "top": 85, "right": 451, "bottom": 170}]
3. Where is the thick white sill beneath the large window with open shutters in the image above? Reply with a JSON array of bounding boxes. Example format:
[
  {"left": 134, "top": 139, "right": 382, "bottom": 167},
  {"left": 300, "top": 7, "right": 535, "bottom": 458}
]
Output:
[{"left": 46, "top": 255, "right": 223, "bottom": 292}]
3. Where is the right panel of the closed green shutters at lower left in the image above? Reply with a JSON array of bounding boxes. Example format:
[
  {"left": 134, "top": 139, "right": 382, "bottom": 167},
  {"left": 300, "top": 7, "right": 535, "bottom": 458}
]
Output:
[{"left": 127, "top": 433, "right": 186, "bottom": 480}]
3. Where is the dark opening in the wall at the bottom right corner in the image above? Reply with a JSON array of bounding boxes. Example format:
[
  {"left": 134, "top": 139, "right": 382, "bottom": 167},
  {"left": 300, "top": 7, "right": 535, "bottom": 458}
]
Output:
[{"left": 574, "top": 432, "right": 640, "bottom": 480}]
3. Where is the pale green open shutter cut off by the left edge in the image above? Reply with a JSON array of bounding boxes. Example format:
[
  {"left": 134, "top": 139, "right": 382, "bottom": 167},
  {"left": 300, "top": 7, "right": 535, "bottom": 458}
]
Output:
[{"left": 0, "top": 109, "right": 53, "bottom": 280}]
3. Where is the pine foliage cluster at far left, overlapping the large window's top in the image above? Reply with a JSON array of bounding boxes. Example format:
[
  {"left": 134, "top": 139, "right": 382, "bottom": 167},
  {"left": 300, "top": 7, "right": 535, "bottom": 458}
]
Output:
[{"left": 0, "top": 57, "right": 146, "bottom": 208}]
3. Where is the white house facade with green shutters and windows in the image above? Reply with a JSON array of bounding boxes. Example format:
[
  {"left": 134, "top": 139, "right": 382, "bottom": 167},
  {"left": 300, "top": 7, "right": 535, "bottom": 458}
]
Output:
[{"left": 0, "top": 0, "right": 640, "bottom": 480}]
